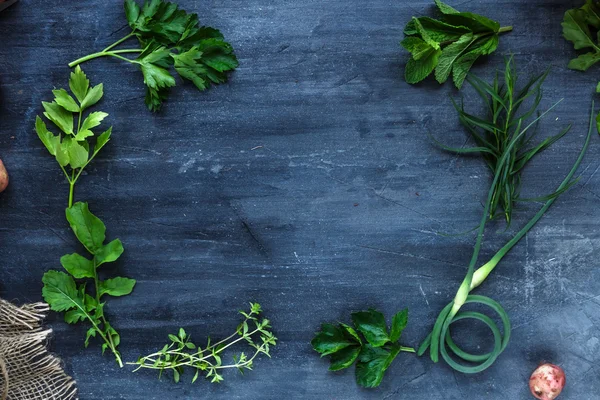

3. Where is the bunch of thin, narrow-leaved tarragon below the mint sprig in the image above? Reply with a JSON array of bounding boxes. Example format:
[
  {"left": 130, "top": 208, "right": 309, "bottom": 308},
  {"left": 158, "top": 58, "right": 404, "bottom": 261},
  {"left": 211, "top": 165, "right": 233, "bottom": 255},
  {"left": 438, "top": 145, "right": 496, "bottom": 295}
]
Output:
[{"left": 434, "top": 57, "right": 571, "bottom": 225}]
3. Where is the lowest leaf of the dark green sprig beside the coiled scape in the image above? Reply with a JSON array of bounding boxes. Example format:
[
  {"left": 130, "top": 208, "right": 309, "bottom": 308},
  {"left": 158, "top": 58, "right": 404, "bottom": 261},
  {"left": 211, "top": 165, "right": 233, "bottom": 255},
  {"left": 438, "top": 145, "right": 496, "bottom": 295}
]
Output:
[{"left": 356, "top": 345, "right": 400, "bottom": 388}]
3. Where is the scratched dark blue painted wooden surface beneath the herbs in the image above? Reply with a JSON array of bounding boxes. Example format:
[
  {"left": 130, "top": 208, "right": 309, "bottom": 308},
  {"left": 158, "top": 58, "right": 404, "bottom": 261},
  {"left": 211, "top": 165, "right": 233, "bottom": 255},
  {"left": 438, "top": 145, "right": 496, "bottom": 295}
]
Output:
[{"left": 0, "top": 0, "right": 600, "bottom": 400}]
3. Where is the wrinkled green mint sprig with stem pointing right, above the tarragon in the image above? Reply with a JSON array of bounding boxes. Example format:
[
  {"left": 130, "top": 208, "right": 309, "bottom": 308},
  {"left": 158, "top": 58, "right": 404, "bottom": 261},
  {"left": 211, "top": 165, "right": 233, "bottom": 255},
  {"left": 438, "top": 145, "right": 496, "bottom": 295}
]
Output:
[{"left": 400, "top": 0, "right": 512, "bottom": 88}]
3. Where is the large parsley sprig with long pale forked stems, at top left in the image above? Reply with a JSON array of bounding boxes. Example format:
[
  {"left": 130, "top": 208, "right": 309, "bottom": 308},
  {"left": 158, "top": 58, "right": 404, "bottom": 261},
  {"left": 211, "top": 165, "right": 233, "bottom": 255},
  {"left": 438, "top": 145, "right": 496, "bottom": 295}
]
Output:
[{"left": 69, "top": 0, "right": 238, "bottom": 111}]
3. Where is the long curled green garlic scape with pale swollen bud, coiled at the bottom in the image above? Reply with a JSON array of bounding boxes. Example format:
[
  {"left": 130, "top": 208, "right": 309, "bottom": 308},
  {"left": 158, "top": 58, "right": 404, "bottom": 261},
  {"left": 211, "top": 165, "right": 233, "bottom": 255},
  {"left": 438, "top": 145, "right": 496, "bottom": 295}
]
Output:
[{"left": 417, "top": 61, "right": 594, "bottom": 373}]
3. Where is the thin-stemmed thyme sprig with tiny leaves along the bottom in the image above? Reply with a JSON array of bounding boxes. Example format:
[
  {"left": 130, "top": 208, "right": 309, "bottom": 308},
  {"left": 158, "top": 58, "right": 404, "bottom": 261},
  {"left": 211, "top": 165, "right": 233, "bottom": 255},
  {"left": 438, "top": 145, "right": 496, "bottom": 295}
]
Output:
[{"left": 128, "top": 303, "right": 277, "bottom": 383}]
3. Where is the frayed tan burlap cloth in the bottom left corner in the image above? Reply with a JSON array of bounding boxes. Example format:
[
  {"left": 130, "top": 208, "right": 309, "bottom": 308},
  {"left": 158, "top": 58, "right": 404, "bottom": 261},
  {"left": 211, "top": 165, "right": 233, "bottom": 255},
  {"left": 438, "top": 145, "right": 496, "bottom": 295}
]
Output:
[{"left": 0, "top": 299, "right": 77, "bottom": 400}]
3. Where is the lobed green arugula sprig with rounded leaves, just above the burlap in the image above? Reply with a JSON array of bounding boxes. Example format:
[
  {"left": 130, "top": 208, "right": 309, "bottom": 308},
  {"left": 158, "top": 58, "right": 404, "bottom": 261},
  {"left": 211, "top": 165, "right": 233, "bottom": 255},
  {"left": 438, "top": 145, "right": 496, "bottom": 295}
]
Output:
[{"left": 42, "top": 202, "right": 135, "bottom": 367}]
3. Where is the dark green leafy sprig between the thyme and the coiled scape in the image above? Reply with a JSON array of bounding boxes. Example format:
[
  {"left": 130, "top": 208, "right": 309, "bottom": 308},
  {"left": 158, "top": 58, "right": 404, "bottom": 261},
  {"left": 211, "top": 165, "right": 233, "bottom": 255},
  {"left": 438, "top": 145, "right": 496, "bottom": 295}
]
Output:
[{"left": 311, "top": 309, "right": 415, "bottom": 388}]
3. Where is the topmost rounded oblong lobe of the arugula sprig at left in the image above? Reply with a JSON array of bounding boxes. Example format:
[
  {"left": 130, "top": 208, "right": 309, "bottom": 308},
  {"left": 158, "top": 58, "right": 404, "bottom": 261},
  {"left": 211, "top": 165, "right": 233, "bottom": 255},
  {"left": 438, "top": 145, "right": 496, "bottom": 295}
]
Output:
[{"left": 66, "top": 202, "right": 106, "bottom": 254}]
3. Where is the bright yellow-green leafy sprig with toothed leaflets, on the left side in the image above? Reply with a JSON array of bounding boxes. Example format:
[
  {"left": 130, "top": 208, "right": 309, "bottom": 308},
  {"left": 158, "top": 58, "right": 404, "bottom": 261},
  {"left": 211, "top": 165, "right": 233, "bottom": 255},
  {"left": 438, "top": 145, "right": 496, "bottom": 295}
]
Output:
[{"left": 35, "top": 67, "right": 112, "bottom": 207}]
